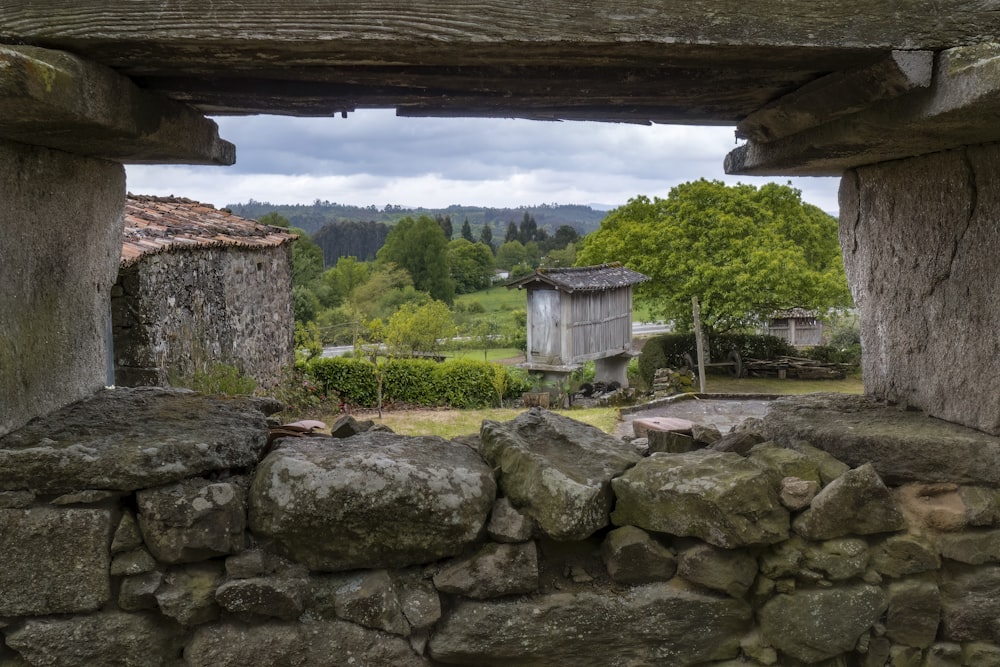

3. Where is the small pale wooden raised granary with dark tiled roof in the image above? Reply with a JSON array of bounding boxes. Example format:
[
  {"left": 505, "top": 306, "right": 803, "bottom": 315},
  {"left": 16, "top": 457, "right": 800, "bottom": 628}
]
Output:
[{"left": 507, "top": 263, "right": 649, "bottom": 387}]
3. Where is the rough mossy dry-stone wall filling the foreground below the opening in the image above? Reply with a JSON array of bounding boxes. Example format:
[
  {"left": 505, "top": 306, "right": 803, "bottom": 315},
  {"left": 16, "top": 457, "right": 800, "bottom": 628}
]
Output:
[{"left": 0, "top": 389, "right": 1000, "bottom": 667}]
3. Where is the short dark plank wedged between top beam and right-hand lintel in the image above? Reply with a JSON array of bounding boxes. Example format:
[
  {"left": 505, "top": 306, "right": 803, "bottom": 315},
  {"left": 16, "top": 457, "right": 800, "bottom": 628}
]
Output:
[{"left": 736, "top": 51, "right": 934, "bottom": 143}]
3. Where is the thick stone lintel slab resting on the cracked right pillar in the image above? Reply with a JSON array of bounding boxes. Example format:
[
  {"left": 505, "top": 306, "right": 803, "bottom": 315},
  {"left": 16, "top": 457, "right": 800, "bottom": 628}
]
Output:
[{"left": 725, "top": 43, "right": 1000, "bottom": 176}]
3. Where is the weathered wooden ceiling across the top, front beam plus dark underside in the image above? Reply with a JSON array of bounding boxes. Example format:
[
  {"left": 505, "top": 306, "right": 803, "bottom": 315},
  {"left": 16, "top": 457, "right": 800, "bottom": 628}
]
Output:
[{"left": 0, "top": 0, "right": 1000, "bottom": 123}]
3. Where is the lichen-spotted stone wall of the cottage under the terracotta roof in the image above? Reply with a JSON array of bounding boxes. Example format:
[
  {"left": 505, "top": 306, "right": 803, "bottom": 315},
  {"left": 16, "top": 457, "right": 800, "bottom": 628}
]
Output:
[{"left": 112, "top": 245, "right": 294, "bottom": 387}]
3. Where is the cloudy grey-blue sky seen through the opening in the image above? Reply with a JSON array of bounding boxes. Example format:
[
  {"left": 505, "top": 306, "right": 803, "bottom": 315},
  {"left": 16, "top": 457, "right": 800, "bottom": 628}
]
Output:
[{"left": 128, "top": 110, "right": 839, "bottom": 214}]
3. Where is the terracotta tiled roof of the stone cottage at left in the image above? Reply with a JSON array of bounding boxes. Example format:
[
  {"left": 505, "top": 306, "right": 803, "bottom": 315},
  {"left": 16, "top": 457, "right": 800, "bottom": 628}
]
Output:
[{"left": 121, "top": 194, "right": 296, "bottom": 268}]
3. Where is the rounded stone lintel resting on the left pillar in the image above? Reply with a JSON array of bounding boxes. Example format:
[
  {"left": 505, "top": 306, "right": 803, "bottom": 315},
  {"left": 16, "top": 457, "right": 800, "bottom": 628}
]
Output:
[{"left": 0, "top": 46, "right": 236, "bottom": 165}]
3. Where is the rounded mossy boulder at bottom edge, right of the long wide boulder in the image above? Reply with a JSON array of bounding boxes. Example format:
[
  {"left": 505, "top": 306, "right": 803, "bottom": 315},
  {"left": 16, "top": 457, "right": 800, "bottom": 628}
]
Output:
[{"left": 758, "top": 584, "right": 886, "bottom": 664}]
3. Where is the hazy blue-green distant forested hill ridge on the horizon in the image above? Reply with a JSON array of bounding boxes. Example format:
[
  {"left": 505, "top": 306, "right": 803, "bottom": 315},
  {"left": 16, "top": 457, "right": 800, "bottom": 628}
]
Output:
[{"left": 226, "top": 199, "right": 607, "bottom": 240}]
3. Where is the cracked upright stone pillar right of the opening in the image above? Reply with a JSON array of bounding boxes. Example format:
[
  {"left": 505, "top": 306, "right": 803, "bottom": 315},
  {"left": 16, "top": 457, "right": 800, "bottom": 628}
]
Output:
[{"left": 840, "top": 144, "right": 1000, "bottom": 434}]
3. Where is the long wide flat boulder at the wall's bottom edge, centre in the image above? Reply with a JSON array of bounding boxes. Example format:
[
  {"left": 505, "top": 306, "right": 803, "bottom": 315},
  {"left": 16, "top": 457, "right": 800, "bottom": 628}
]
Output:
[{"left": 430, "top": 583, "right": 752, "bottom": 667}]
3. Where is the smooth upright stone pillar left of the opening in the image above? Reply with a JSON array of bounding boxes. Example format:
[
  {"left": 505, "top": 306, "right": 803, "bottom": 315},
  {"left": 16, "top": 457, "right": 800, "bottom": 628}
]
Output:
[{"left": 0, "top": 140, "right": 125, "bottom": 435}]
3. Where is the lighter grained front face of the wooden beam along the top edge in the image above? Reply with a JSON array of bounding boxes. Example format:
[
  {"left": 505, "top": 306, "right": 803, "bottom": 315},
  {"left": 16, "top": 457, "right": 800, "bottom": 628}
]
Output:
[{"left": 0, "top": 0, "right": 1000, "bottom": 57}]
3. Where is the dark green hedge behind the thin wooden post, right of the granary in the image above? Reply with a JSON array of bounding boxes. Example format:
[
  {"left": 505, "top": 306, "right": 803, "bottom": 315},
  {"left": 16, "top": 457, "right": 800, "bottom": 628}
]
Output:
[{"left": 639, "top": 333, "right": 798, "bottom": 386}]
